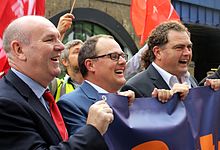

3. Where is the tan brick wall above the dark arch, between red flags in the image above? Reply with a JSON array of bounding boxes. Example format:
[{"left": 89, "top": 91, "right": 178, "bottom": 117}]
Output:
[{"left": 45, "top": 0, "right": 139, "bottom": 47}]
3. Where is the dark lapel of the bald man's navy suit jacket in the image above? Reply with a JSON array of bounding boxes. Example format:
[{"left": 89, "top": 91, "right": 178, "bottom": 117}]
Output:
[{"left": 6, "top": 70, "right": 61, "bottom": 139}]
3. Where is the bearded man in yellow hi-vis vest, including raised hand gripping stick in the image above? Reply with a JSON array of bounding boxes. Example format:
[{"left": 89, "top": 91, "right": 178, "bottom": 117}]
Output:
[{"left": 49, "top": 13, "right": 83, "bottom": 101}]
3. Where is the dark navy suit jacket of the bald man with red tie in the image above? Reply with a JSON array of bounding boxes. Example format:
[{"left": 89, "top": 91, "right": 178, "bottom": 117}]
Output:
[{"left": 0, "top": 71, "right": 107, "bottom": 150}]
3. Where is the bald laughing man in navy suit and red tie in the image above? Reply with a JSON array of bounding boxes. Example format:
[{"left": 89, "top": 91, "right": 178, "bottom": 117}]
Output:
[{"left": 0, "top": 16, "right": 113, "bottom": 150}]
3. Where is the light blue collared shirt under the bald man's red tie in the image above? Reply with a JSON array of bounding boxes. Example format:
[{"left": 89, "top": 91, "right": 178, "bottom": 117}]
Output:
[{"left": 11, "top": 68, "right": 50, "bottom": 112}]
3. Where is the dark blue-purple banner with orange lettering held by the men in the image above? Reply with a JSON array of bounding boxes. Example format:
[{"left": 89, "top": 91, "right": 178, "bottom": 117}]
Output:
[{"left": 101, "top": 87, "right": 220, "bottom": 150}]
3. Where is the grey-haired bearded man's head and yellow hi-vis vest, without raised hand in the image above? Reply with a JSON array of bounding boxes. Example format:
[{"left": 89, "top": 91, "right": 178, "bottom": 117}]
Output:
[{"left": 49, "top": 40, "right": 84, "bottom": 101}]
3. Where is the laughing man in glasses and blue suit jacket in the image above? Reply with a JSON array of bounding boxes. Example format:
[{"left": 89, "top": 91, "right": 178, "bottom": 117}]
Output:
[{"left": 58, "top": 35, "right": 134, "bottom": 135}]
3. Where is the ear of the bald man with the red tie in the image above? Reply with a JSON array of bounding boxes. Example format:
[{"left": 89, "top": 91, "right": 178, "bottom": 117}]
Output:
[{"left": 11, "top": 40, "right": 27, "bottom": 60}]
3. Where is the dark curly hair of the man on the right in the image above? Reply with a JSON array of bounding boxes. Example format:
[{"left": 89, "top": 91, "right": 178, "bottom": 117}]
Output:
[{"left": 141, "top": 20, "right": 190, "bottom": 68}]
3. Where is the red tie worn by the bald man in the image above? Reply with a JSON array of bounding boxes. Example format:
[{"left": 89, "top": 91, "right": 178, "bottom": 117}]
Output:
[{"left": 43, "top": 90, "right": 68, "bottom": 141}]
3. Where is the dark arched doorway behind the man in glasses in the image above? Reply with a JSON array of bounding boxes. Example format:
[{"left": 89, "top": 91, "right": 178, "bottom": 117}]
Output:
[{"left": 50, "top": 8, "right": 138, "bottom": 56}]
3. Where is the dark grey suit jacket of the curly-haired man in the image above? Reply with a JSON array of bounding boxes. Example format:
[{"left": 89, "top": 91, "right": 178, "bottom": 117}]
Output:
[{"left": 121, "top": 64, "right": 197, "bottom": 98}]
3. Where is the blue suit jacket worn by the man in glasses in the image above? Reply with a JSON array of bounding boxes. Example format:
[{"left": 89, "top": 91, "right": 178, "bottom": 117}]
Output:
[{"left": 57, "top": 81, "right": 99, "bottom": 135}]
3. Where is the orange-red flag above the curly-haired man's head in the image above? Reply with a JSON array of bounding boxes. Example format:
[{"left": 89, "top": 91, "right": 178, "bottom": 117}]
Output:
[{"left": 131, "top": 0, "right": 180, "bottom": 45}]
